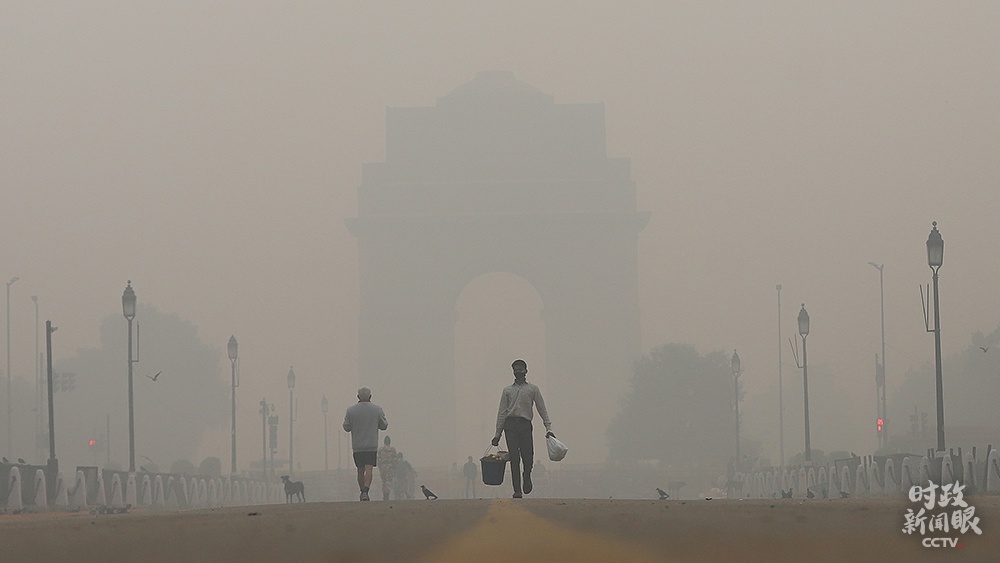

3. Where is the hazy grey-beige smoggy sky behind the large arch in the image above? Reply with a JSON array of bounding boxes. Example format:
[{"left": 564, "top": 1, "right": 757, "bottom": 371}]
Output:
[{"left": 0, "top": 0, "right": 1000, "bottom": 468}]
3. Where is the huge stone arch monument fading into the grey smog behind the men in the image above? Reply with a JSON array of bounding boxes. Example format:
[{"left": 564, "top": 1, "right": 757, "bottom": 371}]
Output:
[{"left": 348, "top": 72, "right": 648, "bottom": 465}]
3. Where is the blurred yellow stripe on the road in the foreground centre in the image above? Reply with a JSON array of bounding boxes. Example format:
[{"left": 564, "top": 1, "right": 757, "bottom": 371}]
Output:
[{"left": 421, "top": 499, "right": 662, "bottom": 563}]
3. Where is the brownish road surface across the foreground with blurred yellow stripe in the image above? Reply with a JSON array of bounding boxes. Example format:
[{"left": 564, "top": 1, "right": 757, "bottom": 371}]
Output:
[{"left": 0, "top": 496, "right": 1000, "bottom": 562}]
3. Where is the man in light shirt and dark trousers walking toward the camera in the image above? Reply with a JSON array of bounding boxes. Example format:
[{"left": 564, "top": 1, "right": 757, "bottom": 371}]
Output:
[{"left": 493, "top": 360, "right": 555, "bottom": 498}]
